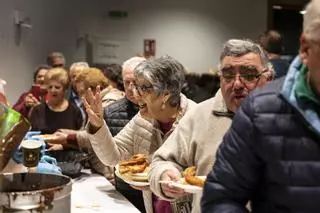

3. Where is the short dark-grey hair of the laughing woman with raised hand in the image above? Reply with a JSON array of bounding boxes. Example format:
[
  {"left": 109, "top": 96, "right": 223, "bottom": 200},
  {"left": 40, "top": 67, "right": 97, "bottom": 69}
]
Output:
[{"left": 134, "top": 56, "right": 186, "bottom": 107}]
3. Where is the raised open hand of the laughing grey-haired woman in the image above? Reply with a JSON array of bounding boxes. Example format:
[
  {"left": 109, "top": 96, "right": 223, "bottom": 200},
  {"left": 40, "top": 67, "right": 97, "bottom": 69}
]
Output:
[{"left": 82, "top": 86, "right": 103, "bottom": 129}]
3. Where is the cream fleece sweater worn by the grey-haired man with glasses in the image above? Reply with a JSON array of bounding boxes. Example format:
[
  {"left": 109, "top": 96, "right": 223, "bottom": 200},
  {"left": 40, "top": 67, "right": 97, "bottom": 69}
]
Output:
[{"left": 149, "top": 90, "right": 231, "bottom": 212}]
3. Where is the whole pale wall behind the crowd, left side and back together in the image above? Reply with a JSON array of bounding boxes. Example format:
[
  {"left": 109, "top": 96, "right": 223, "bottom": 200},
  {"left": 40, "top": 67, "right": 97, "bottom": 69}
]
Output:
[{"left": 0, "top": 0, "right": 267, "bottom": 102}]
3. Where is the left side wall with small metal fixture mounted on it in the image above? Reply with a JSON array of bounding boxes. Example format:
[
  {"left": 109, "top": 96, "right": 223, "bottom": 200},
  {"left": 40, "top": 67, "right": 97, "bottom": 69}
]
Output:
[{"left": 0, "top": 0, "right": 69, "bottom": 103}]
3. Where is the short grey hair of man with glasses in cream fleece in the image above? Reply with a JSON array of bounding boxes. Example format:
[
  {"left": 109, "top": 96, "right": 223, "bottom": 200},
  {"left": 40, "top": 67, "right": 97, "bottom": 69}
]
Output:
[{"left": 219, "top": 39, "right": 275, "bottom": 77}]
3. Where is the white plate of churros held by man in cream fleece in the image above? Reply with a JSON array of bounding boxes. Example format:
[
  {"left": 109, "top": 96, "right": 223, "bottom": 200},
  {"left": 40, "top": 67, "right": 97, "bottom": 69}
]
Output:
[{"left": 159, "top": 166, "right": 207, "bottom": 194}]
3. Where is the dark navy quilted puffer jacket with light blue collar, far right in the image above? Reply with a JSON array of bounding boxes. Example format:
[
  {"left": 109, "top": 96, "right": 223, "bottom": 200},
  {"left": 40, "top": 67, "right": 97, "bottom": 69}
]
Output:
[{"left": 201, "top": 56, "right": 320, "bottom": 213}]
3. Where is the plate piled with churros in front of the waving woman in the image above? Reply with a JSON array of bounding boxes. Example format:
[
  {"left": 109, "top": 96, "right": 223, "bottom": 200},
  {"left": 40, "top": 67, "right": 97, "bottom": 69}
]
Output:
[{"left": 115, "top": 154, "right": 149, "bottom": 186}]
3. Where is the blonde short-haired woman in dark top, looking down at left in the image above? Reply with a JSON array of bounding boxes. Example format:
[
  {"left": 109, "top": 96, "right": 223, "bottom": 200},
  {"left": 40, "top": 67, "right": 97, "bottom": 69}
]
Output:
[{"left": 29, "top": 68, "right": 82, "bottom": 134}]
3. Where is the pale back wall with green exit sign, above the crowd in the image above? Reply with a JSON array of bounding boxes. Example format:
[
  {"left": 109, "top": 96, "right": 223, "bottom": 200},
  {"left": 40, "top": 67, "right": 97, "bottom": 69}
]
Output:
[{"left": 65, "top": 0, "right": 267, "bottom": 72}]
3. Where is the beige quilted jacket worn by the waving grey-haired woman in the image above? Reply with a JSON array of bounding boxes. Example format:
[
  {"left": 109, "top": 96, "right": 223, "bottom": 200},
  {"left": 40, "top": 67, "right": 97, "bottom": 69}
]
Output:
[{"left": 89, "top": 95, "right": 195, "bottom": 213}]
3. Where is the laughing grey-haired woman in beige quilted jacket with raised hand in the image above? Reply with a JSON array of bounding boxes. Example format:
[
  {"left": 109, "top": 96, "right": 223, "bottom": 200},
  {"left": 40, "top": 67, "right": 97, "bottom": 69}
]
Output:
[{"left": 84, "top": 56, "right": 195, "bottom": 213}]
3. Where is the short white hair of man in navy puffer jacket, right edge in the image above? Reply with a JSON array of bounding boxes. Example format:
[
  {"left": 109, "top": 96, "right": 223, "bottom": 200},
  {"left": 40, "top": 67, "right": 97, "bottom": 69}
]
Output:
[{"left": 303, "top": 0, "right": 320, "bottom": 40}]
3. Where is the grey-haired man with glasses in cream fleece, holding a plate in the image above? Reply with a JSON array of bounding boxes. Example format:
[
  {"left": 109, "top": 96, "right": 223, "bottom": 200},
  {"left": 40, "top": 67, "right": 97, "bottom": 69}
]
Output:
[{"left": 149, "top": 39, "right": 274, "bottom": 212}]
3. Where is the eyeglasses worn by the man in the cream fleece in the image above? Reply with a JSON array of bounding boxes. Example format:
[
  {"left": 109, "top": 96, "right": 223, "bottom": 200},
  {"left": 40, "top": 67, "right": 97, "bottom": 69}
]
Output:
[{"left": 220, "top": 66, "right": 268, "bottom": 84}]
